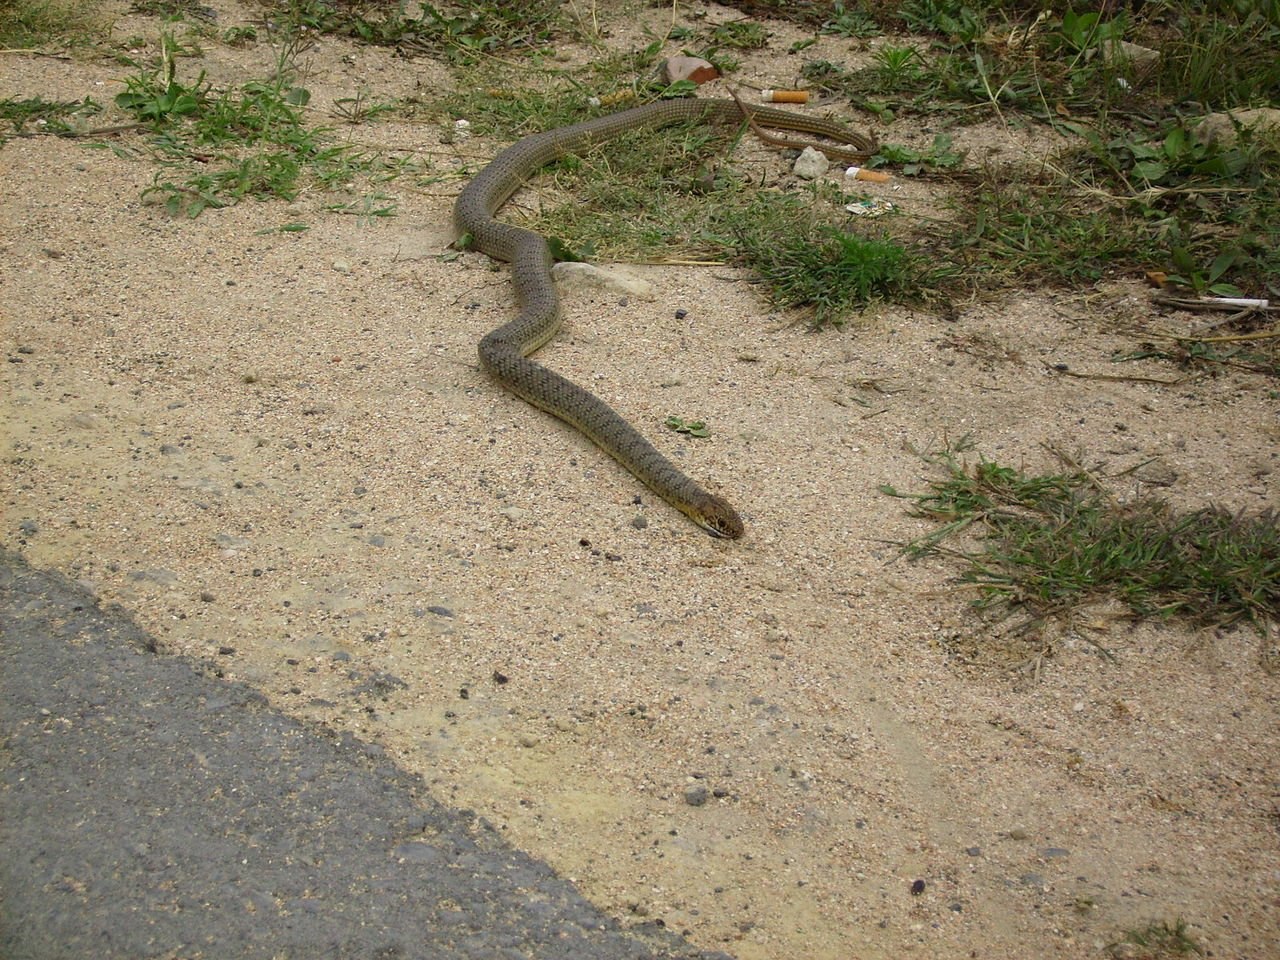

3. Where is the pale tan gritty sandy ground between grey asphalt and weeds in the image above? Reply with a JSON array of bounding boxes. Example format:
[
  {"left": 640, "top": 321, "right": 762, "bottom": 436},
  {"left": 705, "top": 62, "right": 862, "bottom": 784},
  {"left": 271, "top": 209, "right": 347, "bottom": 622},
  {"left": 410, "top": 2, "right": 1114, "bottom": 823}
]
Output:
[{"left": 0, "top": 3, "right": 1280, "bottom": 960}]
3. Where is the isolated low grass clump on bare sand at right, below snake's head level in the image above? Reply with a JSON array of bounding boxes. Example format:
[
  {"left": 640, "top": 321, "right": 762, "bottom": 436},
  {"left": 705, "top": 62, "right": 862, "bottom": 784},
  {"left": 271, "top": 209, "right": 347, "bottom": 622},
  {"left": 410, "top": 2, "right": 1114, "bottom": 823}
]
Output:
[{"left": 881, "top": 444, "right": 1280, "bottom": 655}]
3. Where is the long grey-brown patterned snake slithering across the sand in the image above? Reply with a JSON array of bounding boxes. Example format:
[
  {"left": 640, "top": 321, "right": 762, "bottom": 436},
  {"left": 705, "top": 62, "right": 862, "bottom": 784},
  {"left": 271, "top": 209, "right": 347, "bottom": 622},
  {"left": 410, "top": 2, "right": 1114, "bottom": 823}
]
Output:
[{"left": 453, "top": 97, "right": 874, "bottom": 540}]
